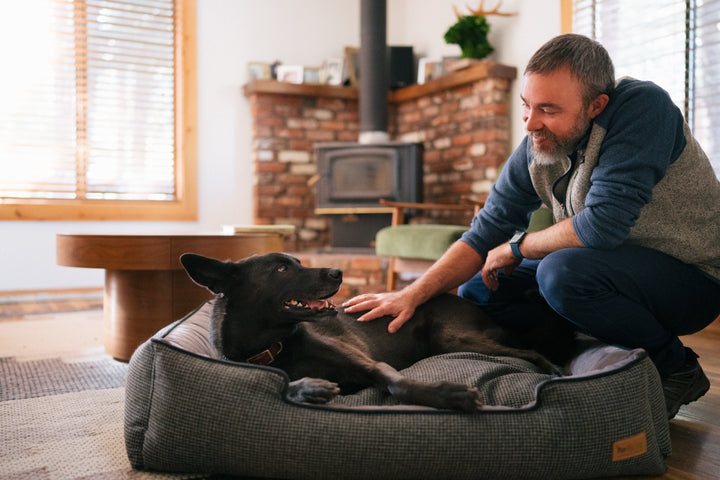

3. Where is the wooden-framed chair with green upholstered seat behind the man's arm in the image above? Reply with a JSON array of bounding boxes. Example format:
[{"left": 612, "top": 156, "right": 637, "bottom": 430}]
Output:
[{"left": 375, "top": 201, "right": 552, "bottom": 291}]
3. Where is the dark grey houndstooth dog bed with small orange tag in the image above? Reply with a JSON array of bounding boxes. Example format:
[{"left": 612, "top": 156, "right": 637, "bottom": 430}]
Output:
[{"left": 125, "top": 303, "right": 670, "bottom": 480}]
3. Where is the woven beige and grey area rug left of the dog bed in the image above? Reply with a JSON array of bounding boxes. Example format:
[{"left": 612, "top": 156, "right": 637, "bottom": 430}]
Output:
[{"left": 0, "top": 332, "right": 231, "bottom": 480}]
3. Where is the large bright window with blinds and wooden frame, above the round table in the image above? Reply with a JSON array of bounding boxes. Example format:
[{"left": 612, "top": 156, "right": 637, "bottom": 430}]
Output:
[{"left": 0, "top": 0, "right": 197, "bottom": 220}]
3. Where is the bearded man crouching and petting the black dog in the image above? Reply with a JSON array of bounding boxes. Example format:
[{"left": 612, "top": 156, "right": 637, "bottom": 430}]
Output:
[{"left": 346, "top": 34, "right": 720, "bottom": 418}]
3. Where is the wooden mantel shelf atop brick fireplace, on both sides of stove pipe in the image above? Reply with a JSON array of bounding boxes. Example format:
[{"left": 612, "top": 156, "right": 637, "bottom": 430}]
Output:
[{"left": 243, "top": 60, "right": 517, "bottom": 103}]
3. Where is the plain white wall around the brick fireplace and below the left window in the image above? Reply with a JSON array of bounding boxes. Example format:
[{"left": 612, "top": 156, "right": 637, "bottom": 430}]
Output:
[{"left": 0, "top": 0, "right": 560, "bottom": 290}]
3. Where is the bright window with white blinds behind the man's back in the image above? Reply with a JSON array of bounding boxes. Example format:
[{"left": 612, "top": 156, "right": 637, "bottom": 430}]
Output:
[{"left": 572, "top": 0, "right": 720, "bottom": 177}]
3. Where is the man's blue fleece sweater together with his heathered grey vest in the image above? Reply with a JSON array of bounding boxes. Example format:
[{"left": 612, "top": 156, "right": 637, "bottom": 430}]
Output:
[{"left": 461, "top": 79, "right": 720, "bottom": 278}]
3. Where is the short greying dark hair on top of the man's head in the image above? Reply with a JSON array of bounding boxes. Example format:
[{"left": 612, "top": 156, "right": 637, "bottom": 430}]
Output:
[{"left": 525, "top": 33, "right": 615, "bottom": 105}]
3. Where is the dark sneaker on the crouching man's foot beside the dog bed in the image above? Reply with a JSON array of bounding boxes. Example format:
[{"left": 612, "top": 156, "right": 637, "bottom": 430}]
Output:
[{"left": 662, "top": 347, "right": 710, "bottom": 420}]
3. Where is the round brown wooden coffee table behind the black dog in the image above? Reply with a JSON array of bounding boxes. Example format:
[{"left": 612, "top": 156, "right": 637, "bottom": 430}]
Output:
[{"left": 57, "top": 231, "right": 283, "bottom": 361}]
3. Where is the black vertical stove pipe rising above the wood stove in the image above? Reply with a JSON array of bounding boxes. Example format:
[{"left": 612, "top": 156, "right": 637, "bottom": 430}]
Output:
[{"left": 358, "top": 0, "right": 390, "bottom": 144}]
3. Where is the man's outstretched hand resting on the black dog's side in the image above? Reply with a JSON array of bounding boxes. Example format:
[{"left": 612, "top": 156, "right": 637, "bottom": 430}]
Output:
[{"left": 343, "top": 290, "right": 417, "bottom": 333}]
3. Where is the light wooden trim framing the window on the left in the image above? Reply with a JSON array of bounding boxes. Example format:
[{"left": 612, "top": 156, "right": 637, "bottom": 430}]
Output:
[{"left": 0, "top": 0, "right": 198, "bottom": 221}]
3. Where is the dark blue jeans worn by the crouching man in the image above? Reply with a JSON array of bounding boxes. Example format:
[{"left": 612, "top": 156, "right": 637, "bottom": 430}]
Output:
[{"left": 458, "top": 245, "right": 720, "bottom": 376}]
